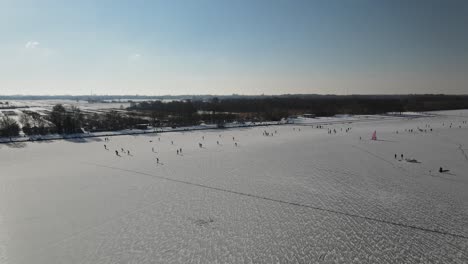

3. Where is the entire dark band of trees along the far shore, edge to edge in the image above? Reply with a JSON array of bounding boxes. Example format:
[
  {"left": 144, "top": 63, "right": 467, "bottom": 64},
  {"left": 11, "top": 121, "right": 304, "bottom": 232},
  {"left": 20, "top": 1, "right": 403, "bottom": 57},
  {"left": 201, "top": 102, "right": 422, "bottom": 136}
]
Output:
[{"left": 0, "top": 95, "right": 468, "bottom": 137}]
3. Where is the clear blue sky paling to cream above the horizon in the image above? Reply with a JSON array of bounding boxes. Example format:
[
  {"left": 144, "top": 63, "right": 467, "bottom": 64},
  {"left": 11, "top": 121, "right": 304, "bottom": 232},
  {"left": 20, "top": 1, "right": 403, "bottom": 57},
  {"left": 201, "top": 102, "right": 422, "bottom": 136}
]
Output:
[{"left": 0, "top": 0, "right": 468, "bottom": 95}]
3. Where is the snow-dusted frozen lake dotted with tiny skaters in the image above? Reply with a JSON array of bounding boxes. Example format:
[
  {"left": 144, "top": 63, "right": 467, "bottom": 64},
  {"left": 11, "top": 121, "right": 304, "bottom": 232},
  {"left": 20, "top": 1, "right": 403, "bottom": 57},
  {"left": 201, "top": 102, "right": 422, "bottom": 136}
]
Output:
[{"left": 0, "top": 111, "right": 468, "bottom": 264}]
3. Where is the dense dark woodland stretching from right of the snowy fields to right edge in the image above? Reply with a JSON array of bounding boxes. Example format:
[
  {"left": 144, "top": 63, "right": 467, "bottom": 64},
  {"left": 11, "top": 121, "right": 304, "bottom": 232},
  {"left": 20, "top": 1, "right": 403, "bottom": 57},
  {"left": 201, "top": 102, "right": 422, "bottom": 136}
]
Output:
[{"left": 129, "top": 95, "right": 468, "bottom": 123}]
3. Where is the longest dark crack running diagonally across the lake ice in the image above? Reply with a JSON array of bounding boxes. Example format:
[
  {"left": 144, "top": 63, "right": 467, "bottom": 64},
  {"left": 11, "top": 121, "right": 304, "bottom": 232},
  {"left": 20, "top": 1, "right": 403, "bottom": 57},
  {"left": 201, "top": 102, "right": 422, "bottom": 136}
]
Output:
[{"left": 84, "top": 162, "right": 468, "bottom": 239}]
